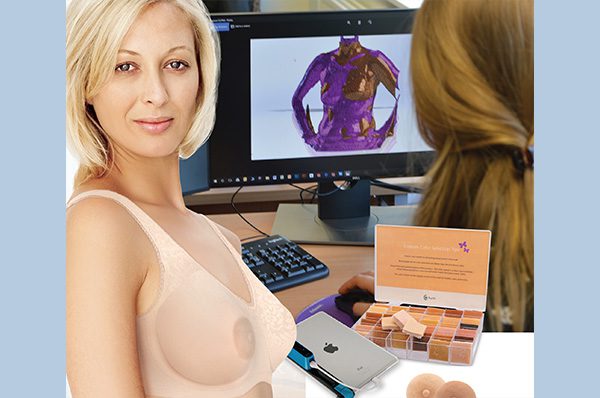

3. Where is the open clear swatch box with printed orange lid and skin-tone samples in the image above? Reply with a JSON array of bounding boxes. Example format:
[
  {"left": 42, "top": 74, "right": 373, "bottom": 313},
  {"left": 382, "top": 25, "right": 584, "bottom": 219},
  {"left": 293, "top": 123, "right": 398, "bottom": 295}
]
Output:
[{"left": 352, "top": 225, "right": 491, "bottom": 365}]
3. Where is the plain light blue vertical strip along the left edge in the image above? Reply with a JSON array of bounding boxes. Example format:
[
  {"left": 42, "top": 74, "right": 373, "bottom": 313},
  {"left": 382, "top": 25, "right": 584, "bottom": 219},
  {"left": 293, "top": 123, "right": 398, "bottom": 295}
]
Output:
[{"left": 0, "top": 1, "right": 65, "bottom": 398}]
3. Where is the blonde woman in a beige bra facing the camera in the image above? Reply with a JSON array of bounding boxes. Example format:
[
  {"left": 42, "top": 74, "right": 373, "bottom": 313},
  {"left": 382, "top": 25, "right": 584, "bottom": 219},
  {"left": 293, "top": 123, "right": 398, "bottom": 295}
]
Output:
[{"left": 66, "top": 0, "right": 295, "bottom": 398}]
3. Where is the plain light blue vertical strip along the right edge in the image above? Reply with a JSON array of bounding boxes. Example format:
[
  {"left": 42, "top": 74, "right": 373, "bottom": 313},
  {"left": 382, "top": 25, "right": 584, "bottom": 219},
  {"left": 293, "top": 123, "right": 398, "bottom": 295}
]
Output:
[{"left": 536, "top": 1, "right": 600, "bottom": 398}]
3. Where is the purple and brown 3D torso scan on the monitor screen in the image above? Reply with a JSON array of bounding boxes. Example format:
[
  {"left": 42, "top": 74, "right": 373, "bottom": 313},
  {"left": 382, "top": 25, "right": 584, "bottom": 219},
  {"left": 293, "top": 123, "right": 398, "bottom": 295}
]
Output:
[{"left": 292, "top": 36, "right": 400, "bottom": 151}]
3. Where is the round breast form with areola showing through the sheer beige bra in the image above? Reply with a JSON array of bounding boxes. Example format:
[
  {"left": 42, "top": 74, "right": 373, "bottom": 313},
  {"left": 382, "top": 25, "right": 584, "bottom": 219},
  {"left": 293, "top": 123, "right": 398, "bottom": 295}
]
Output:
[{"left": 156, "top": 271, "right": 256, "bottom": 386}]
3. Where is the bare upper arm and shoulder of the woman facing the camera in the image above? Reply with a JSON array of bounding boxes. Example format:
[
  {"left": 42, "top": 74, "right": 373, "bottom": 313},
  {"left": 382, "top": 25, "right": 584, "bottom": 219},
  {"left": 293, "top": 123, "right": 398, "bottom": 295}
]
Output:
[{"left": 66, "top": 198, "right": 152, "bottom": 398}]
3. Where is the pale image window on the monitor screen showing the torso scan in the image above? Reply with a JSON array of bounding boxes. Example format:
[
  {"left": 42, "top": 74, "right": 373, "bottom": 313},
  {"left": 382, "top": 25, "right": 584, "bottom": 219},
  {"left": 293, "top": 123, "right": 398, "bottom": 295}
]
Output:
[{"left": 250, "top": 34, "right": 430, "bottom": 161}]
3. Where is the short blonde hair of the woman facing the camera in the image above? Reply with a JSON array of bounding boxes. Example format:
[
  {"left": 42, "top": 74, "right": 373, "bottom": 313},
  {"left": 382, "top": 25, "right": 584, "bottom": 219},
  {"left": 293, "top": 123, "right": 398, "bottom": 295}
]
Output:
[{"left": 66, "top": 0, "right": 220, "bottom": 187}]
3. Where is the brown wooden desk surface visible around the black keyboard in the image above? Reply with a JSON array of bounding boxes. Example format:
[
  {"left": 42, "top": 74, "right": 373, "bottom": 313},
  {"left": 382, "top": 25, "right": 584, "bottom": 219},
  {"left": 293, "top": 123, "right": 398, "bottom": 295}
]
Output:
[{"left": 208, "top": 213, "right": 373, "bottom": 318}]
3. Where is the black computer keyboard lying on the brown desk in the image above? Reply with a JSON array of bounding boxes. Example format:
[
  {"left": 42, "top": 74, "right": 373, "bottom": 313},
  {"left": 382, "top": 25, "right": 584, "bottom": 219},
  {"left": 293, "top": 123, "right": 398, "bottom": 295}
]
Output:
[{"left": 242, "top": 235, "right": 329, "bottom": 292}]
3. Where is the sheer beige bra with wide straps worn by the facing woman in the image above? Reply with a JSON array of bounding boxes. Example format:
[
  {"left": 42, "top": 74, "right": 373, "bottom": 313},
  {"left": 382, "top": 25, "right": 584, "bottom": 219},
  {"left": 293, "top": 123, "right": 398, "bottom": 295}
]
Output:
[{"left": 68, "top": 190, "right": 296, "bottom": 398}]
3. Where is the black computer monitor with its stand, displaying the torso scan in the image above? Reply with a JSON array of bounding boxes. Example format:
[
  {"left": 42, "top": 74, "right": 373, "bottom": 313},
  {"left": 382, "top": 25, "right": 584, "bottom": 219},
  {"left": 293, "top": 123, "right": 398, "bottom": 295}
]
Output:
[{"left": 209, "top": 9, "right": 433, "bottom": 244}]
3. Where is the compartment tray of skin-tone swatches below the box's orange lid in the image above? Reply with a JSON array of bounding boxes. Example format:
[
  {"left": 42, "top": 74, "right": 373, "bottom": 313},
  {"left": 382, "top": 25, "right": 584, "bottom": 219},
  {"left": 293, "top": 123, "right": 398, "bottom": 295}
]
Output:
[{"left": 353, "top": 303, "right": 483, "bottom": 365}]
